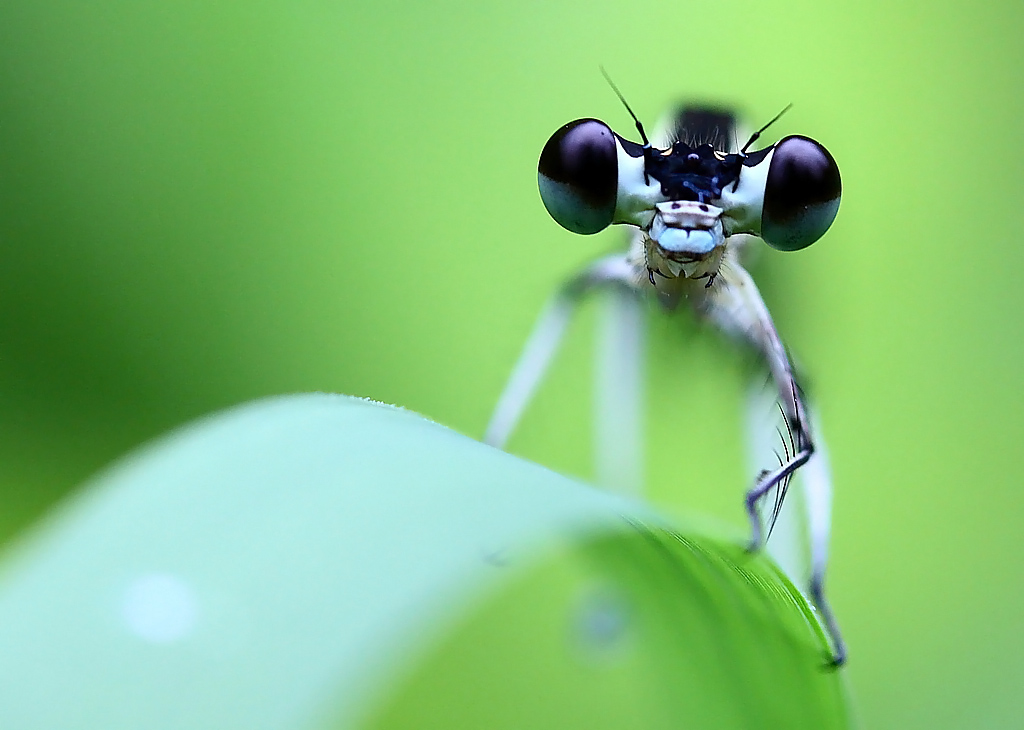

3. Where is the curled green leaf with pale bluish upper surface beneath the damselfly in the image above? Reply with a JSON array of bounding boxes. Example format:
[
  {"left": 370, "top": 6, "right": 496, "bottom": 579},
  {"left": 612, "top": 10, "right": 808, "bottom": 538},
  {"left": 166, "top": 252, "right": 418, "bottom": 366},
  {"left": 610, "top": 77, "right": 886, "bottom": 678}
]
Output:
[{"left": 0, "top": 395, "right": 846, "bottom": 729}]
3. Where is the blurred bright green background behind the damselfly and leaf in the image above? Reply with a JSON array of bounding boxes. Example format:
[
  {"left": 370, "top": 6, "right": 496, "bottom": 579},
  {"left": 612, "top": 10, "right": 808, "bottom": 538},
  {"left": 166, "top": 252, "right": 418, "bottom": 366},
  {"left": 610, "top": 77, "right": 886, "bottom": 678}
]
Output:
[{"left": 0, "top": 0, "right": 1024, "bottom": 728}]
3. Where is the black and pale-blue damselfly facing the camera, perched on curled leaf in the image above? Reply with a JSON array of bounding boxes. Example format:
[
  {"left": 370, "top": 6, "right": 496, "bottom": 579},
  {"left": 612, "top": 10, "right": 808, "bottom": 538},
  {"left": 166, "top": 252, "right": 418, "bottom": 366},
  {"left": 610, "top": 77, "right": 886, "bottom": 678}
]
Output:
[{"left": 484, "top": 79, "right": 846, "bottom": 665}]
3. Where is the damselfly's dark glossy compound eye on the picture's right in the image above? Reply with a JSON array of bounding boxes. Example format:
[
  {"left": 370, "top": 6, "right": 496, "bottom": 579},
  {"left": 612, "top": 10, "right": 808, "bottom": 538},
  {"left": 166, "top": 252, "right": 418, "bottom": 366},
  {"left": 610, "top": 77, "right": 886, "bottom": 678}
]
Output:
[{"left": 761, "top": 136, "right": 843, "bottom": 251}]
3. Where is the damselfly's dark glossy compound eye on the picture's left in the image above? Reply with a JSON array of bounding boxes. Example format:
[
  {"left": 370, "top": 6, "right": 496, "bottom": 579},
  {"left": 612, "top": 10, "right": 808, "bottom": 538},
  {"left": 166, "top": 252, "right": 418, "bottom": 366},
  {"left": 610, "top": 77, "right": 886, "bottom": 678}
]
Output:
[{"left": 537, "top": 119, "right": 618, "bottom": 233}]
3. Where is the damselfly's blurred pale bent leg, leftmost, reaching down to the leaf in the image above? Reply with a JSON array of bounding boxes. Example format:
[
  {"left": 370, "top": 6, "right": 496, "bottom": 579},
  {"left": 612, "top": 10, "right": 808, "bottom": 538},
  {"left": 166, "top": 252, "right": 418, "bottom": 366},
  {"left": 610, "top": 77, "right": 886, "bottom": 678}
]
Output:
[{"left": 483, "top": 255, "right": 636, "bottom": 448}]
